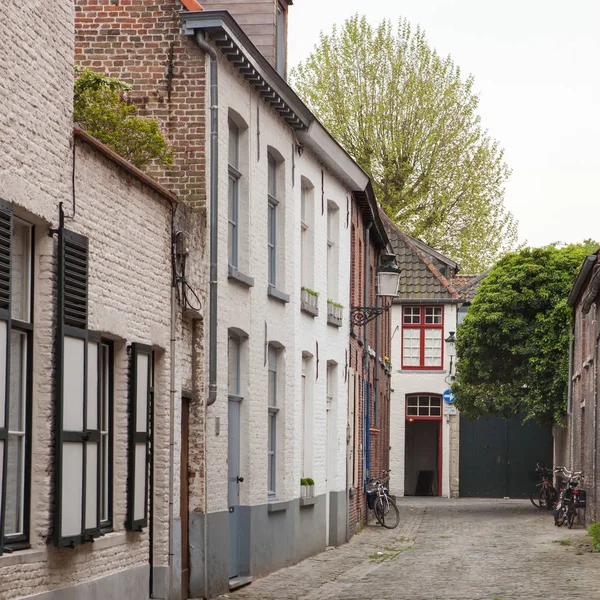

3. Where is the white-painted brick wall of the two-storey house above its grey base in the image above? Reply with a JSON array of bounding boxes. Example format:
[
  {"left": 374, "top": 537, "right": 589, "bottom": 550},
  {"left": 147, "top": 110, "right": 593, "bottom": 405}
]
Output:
[{"left": 207, "top": 61, "right": 350, "bottom": 512}]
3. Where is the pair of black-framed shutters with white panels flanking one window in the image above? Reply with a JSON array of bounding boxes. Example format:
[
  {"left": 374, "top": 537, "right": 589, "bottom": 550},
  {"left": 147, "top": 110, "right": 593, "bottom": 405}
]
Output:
[{"left": 54, "top": 223, "right": 153, "bottom": 547}]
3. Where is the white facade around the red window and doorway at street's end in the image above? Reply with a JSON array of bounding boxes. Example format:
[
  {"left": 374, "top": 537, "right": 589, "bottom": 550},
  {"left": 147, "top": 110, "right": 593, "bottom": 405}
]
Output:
[{"left": 390, "top": 304, "right": 459, "bottom": 497}]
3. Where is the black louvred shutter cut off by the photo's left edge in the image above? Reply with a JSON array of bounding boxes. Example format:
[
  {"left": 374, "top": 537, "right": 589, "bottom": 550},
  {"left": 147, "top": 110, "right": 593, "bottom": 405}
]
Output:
[{"left": 0, "top": 200, "right": 13, "bottom": 556}]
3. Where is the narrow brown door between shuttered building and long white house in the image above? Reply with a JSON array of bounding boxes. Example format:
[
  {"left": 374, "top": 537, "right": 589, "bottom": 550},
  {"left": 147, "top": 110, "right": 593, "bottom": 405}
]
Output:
[{"left": 179, "top": 391, "right": 191, "bottom": 600}]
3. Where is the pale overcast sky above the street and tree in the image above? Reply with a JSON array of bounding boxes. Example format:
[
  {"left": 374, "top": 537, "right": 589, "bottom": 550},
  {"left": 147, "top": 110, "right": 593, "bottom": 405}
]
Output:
[{"left": 289, "top": 0, "right": 600, "bottom": 246}]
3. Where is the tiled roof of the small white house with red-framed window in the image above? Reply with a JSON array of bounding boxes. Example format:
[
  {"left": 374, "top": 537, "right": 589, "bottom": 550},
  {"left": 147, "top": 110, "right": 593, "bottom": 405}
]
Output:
[{"left": 380, "top": 211, "right": 460, "bottom": 302}]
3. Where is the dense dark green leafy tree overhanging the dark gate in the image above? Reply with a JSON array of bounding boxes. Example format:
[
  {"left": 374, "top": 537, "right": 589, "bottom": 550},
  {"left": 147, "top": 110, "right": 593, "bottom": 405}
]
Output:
[{"left": 452, "top": 242, "right": 598, "bottom": 424}]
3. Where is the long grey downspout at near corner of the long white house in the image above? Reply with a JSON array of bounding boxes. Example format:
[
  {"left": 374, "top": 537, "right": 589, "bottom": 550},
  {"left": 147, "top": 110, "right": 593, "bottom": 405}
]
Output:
[{"left": 195, "top": 32, "right": 219, "bottom": 598}]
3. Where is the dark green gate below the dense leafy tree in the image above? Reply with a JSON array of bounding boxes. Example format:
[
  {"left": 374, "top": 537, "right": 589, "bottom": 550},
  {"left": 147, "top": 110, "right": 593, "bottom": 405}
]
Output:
[{"left": 459, "top": 416, "right": 552, "bottom": 498}]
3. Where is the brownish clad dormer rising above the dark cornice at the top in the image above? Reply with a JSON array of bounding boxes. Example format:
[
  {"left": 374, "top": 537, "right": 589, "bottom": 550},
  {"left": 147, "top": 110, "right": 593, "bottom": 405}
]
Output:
[{"left": 201, "top": 0, "right": 293, "bottom": 79}]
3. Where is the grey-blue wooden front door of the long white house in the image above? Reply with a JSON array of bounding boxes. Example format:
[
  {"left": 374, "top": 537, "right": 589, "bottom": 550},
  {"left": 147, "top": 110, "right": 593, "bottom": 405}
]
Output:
[{"left": 227, "top": 400, "right": 241, "bottom": 578}]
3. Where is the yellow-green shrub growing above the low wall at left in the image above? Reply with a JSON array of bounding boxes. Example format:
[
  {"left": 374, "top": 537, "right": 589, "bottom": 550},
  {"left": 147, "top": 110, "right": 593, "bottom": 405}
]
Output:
[{"left": 73, "top": 69, "right": 173, "bottom": 169}]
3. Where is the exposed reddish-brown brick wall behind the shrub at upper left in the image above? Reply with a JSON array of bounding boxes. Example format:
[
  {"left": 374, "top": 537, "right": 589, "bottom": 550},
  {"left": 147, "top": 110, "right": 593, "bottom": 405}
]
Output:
[{"left": 75, "top": 0, "right": 206, "bottom": 209}]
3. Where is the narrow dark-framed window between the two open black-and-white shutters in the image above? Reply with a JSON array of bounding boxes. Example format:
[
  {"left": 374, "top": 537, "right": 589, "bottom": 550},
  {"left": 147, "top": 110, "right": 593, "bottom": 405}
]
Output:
[{"left": 98, "top": 340, "right": 113, "bottom": 530}]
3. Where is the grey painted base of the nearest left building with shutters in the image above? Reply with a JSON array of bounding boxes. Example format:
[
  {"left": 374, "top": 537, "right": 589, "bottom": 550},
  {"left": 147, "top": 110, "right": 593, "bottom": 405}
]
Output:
[{"left": 27, "top": 565, "right": 150, "bottom": 600}]
